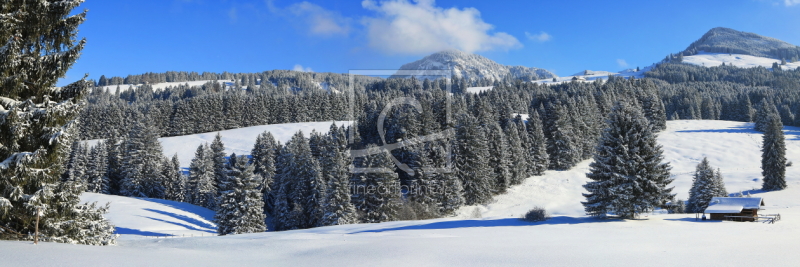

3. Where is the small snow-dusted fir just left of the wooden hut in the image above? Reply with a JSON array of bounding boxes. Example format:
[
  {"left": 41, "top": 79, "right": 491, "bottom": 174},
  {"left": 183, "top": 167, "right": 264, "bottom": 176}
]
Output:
[{"left": 686, "top": 158, "right": 728, "bottom": 213}]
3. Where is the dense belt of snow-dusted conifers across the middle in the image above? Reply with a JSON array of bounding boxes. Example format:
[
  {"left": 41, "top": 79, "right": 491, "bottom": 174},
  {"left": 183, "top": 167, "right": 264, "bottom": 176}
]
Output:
[{"left": 65, "top": 74, "right": 666, "bottom": 234}]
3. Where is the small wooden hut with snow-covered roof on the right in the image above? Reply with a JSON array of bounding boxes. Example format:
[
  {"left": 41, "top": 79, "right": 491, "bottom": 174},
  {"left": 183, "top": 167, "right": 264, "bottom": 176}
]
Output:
[{"left": 704, "top": 197, "right": 764, "bottom": 222}]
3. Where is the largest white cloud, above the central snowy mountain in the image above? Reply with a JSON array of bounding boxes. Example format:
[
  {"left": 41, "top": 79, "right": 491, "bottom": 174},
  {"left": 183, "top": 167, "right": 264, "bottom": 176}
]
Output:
[{"left": 361, "top": 0, "right": 522, "bottom": 54}]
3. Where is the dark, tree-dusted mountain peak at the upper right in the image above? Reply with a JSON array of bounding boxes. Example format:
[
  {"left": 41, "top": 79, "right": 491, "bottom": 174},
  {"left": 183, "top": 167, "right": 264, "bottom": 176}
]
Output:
[{"left": 683, "top": 27, "right": 800, "bottom": 62}]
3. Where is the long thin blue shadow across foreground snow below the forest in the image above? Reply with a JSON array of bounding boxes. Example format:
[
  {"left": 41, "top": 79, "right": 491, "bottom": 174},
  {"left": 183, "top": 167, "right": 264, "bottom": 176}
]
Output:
[{"left": 354, "top": 216, "right": 623, "bottom": 234}]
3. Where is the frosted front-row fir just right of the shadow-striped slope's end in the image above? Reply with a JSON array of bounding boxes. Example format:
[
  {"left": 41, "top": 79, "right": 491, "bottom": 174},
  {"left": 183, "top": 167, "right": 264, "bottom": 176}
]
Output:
[{"left": 214, "top": 154, "right": 267, "bottom": 235}]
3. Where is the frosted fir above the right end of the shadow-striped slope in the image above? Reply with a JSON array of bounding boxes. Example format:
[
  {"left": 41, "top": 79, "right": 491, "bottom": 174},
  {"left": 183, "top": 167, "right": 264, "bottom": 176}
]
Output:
[{"left": 187, "top": 145, "right": 217, "bottom": 209}]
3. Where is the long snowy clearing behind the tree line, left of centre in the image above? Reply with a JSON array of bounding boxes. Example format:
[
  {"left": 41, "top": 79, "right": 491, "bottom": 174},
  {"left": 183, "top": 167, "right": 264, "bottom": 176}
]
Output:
[{"left": 87, "top": 121, "right": 350, "bottom": 168}]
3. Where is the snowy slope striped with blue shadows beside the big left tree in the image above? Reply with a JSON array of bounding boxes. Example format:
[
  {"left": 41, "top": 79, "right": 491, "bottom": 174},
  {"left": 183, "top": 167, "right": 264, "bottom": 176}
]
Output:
[{"left": 81, "top": 193, "right": 217, "bottom": 239}]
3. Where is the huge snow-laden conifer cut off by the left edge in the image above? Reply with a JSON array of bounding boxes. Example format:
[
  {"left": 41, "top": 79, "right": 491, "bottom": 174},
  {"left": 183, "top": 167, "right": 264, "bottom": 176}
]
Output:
[{"left": 0, "top": 0, "right": 115, "bottom": 245}]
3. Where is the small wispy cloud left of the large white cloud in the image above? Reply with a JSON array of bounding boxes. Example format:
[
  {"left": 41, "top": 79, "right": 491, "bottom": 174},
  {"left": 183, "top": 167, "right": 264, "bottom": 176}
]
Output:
[{"left": 288, "top": 1, "right": 350, "bottom": 36}]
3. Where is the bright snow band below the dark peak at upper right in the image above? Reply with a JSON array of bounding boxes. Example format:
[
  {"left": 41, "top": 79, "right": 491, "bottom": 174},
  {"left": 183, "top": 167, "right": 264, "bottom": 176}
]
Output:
[{"left": 683, "top": 52, "right": 800, "bottom": 70}]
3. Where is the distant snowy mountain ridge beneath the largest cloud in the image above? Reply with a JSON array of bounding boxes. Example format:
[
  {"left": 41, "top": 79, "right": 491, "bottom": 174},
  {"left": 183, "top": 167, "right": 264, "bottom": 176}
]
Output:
[{"left": 400, "top": 50, "right": 557, "bottom": 80}]
